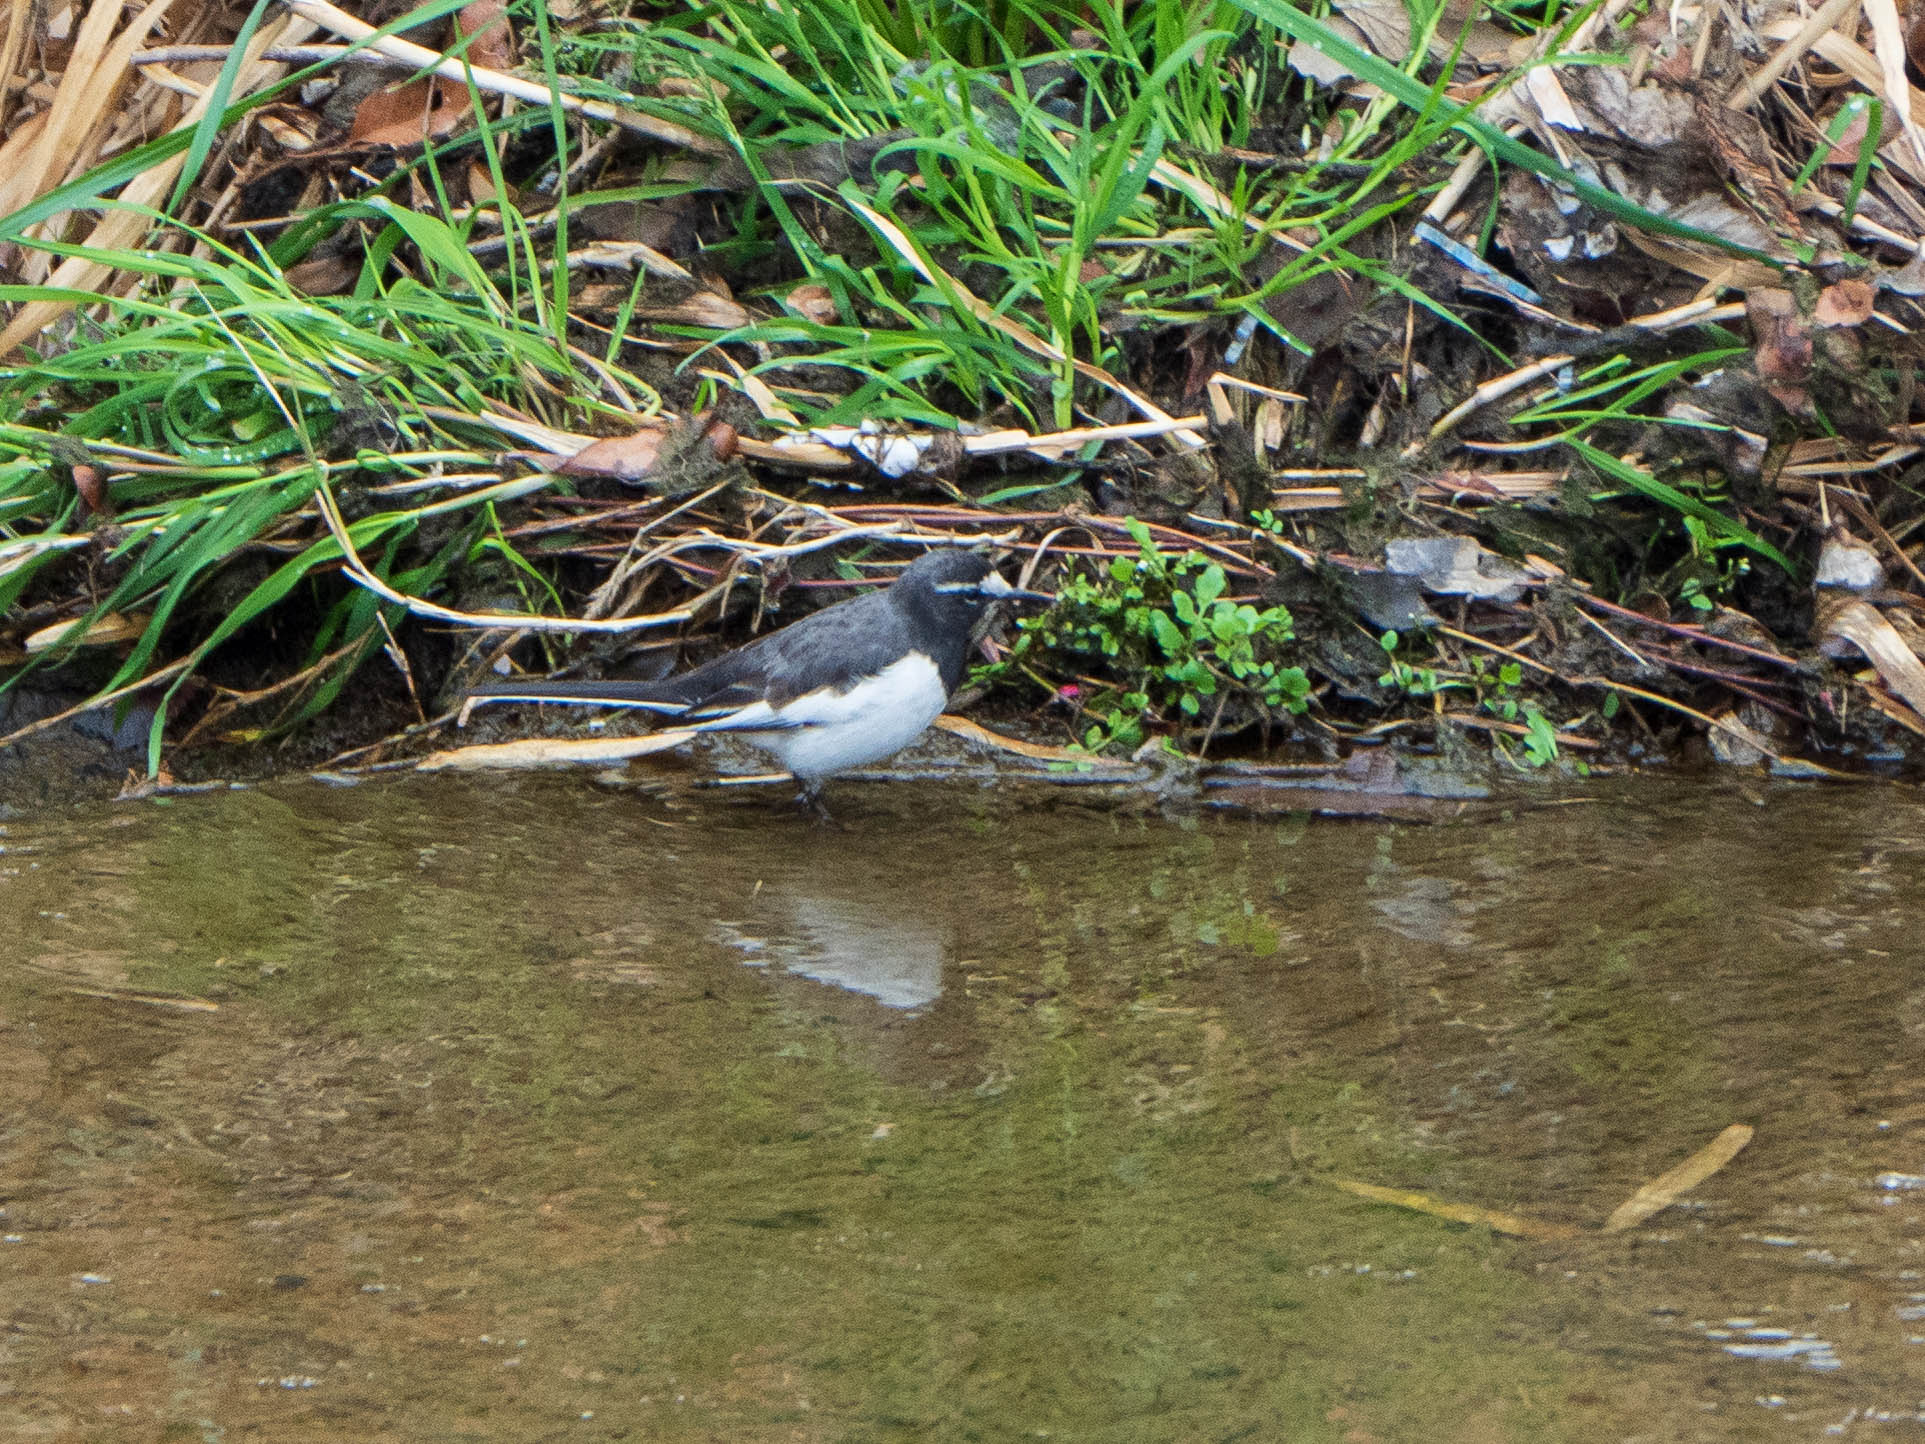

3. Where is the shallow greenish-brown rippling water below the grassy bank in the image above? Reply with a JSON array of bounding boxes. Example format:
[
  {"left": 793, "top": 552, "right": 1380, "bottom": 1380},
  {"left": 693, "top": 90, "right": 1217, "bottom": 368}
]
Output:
[{"left": 0, "top": 778, "right": 1925, "bottom": 1444}]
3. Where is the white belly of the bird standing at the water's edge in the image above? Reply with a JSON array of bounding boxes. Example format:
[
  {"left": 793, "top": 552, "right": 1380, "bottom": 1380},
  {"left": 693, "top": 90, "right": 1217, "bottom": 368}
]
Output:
[{"left": 730, "top": 653, "right": 949, "bottom": 782}]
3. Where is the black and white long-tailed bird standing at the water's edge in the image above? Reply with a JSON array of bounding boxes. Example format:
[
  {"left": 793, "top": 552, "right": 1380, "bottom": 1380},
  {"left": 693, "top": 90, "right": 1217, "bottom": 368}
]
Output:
[{"left": 470, "top": 551, "right": 1055, "bottom": 809}]
